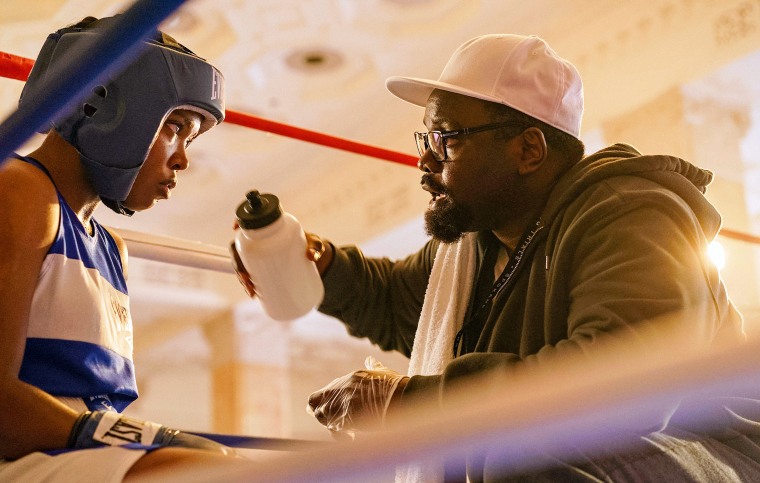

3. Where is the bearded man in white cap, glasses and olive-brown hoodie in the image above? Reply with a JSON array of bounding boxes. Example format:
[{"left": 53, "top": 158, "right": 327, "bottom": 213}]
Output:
[{"left": 235, "top": 35, "right": 760, "bottom": 481}]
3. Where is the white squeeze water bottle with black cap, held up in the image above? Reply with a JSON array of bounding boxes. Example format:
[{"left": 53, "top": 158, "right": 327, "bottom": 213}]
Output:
[{"left": 235, "top": 190, "right": 325, "bottom": 320}]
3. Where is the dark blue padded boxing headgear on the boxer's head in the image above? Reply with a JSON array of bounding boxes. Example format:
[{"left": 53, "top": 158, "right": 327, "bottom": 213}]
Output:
[{"left": 19, "top": 17, "right": 224, "bottom": 215}]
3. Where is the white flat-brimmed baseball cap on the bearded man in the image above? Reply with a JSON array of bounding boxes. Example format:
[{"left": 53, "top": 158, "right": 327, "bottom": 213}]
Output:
[{"left": 385, "top": 34, "right": 583, "bottom": 138}]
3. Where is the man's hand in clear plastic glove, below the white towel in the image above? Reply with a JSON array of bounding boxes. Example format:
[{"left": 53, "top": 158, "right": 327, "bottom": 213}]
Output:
[{"left": 306, "top": 356, "right": 409, "bottom": 435}]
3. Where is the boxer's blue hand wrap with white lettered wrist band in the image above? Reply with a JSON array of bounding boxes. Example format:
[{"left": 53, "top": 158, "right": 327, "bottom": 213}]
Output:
[{"left": 68, "top": 411, "right": 238, "bottom": 457}]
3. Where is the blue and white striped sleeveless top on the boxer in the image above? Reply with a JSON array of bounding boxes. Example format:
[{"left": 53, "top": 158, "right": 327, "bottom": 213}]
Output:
[{"left": 18, "top": 156, "right": 137, "bottom": 411}]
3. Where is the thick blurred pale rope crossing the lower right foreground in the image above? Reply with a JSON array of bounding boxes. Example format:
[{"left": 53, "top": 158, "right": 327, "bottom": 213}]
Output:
[{"left": 151, "top": 318, "right": 760, "bottom": 483}]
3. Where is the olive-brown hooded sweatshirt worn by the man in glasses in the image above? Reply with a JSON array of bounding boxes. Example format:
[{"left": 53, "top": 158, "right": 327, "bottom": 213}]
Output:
[{"left": 320, "top": 144, "right": 744, "bottom": 480}]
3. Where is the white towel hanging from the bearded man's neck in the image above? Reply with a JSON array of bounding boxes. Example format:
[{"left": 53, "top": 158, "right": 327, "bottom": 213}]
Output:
[{"left": 396, "top": 233, "right": 477, "bottom": 483}]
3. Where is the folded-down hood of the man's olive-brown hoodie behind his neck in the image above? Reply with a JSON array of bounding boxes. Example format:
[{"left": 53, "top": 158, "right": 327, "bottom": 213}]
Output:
[{"left": 542, "top": 144, "right": 721, "bottom": 240}]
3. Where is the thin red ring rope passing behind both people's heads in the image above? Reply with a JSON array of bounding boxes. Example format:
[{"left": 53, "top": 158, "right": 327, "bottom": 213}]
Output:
[{"left": 0, "top": 52, "right": 760, "bottom": 245}]
